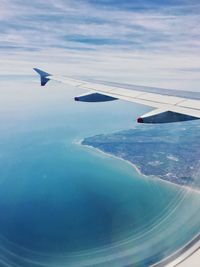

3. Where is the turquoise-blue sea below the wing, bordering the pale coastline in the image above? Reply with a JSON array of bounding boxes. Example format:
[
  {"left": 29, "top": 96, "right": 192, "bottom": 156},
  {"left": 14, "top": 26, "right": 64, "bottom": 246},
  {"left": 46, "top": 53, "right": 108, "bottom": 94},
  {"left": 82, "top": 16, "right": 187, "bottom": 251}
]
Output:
[{"left": 0, "top": 78, "right": 200, "bottom": 267}]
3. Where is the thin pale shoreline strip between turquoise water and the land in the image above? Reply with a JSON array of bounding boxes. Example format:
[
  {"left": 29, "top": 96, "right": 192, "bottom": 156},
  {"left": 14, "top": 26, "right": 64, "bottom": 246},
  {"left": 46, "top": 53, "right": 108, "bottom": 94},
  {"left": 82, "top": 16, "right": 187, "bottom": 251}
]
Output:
[{"left": 73, "top": 139, "right": 200, "bottom": 194}]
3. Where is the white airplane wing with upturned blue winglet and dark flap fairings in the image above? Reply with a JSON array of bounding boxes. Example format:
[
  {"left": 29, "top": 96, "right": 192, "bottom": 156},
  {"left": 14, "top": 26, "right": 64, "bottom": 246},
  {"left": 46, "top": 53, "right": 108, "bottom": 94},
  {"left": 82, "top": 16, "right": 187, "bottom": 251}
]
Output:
[{"left": 34, "top": 68, "right": 200, "bottom": 123}]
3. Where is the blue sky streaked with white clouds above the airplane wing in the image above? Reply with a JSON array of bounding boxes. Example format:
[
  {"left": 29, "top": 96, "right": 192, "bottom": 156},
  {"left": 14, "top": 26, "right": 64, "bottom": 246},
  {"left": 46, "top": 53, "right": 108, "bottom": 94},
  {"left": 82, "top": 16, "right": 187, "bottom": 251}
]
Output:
[{"left": 0, "top": 0, "right": 200, "bottom": 90}]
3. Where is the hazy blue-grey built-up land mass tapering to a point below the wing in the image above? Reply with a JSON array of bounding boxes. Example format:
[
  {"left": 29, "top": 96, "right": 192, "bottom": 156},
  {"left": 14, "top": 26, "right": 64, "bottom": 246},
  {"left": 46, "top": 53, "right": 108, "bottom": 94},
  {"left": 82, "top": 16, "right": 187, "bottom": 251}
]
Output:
[{"left": 82, "top": 122, "right": 200, "bottom": 189}]
